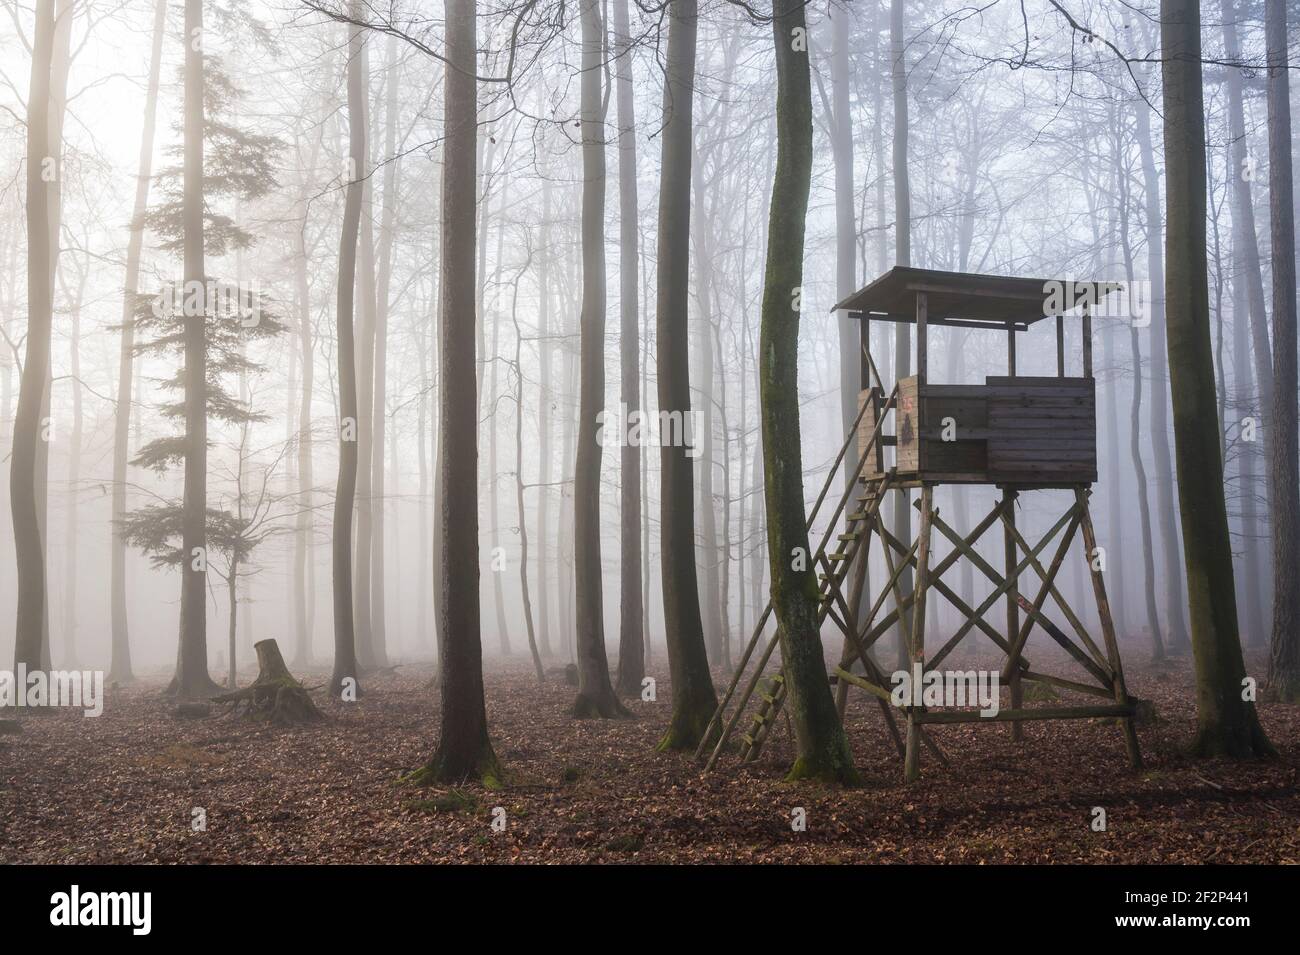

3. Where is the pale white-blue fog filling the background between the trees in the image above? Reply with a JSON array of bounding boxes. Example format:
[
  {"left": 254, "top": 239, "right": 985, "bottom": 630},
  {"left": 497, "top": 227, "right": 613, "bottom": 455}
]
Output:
[{"left": 0, "top": 0, "right": 1289, "bottom": 696}]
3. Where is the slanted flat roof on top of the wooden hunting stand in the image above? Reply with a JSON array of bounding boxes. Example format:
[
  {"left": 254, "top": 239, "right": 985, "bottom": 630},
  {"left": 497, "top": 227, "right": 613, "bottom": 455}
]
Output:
[{"left": 831, "top": 265, "right": 1121, "bottom": 330}]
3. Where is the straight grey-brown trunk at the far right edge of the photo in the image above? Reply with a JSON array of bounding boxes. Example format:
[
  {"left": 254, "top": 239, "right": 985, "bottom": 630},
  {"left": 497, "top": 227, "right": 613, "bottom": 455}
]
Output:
[{"left": 1264, "top": 0, "right": 1300, "bottom": 703}]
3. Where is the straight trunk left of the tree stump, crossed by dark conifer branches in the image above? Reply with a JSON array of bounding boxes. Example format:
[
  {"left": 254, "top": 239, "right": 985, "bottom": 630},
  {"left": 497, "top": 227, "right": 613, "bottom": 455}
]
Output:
[{"left": 174, "top": 0, "right": 220, "bottom": 699}]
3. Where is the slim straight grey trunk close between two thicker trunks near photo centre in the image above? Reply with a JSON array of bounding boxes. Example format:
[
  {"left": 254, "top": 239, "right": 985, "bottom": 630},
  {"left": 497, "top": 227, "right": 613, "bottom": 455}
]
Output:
[{"left": 613, "top": 0, "right": 646, "bottom": 696}]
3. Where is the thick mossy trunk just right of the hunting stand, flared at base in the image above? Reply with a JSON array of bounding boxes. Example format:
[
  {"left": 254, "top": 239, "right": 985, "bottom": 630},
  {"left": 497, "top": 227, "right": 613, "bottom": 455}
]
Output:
[{"left": 1160, "top": 0, "right": 1271, "bottom": 756}]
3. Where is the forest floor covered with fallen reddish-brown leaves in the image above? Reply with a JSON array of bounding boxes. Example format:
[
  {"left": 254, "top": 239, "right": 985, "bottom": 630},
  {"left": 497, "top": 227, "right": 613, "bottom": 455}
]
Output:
[{"left": 0, "top": 648, "right": 1300, "bottom": 863}]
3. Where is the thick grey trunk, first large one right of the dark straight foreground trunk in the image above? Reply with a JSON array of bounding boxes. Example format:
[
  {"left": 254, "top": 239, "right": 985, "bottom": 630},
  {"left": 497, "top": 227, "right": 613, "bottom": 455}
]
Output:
[{"left": 573, "top": 0, "right": 624, "bottom": 717}]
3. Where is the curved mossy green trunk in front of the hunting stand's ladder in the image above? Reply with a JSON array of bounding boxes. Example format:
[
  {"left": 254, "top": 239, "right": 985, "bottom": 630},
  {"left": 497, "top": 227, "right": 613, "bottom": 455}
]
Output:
[{"left": 759, "top": 0, "right": 858, "bottom": 783}]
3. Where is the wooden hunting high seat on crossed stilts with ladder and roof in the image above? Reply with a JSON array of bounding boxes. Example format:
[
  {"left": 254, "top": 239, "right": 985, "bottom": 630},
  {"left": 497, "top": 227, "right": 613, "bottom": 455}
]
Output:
[{"left": 697, "top": 266, "right": 1141, "bottom": 781}]
